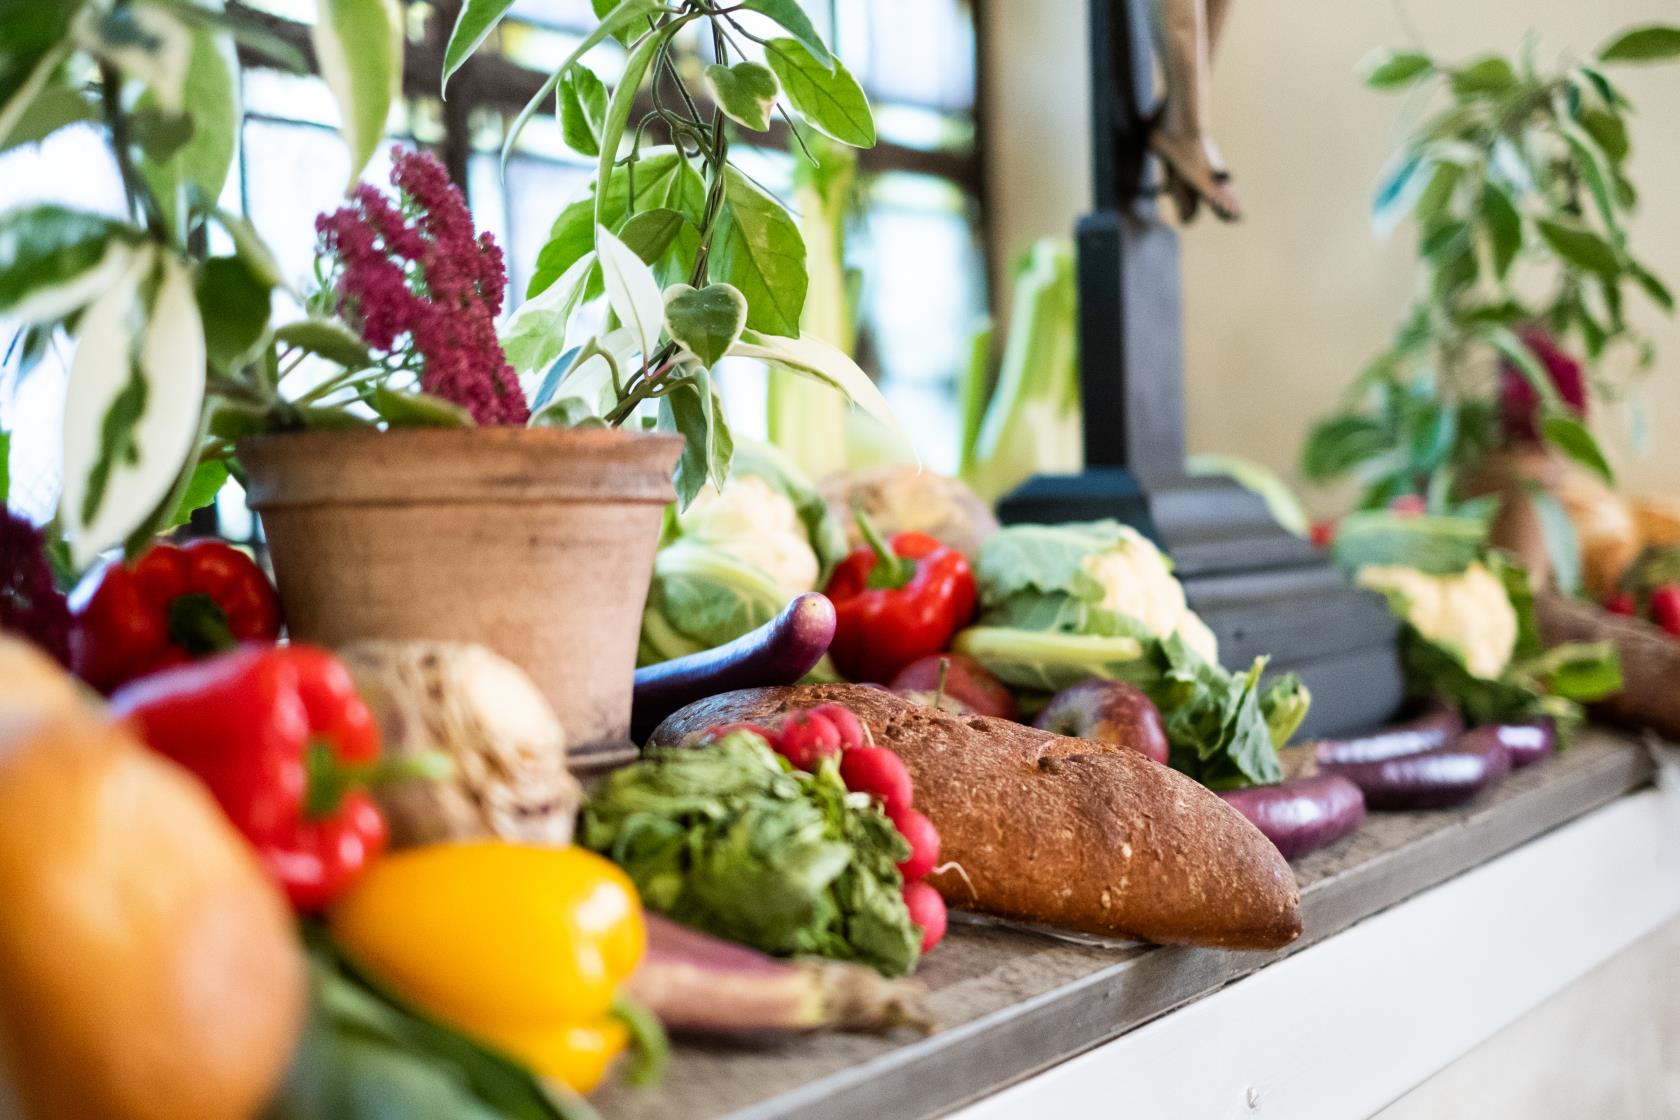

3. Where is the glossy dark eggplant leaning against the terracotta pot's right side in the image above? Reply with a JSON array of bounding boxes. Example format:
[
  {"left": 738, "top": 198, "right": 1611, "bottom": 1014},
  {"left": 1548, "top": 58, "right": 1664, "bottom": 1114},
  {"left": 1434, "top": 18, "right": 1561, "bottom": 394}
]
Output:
[{"left": 630, "top": 591, "right": 835, "bottom": 742}]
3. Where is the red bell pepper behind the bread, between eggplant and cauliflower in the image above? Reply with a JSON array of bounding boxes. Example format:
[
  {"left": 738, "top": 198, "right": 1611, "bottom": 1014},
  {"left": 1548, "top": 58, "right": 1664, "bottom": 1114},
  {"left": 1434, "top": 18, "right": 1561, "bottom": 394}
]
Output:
[{"left": 827, "top": 512, "right": 978, "bottom": 683}]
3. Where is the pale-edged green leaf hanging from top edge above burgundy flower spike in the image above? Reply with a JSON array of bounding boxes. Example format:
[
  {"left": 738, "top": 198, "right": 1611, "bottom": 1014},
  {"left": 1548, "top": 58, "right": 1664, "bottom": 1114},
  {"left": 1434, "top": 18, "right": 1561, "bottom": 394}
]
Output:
[{"left": 311, "top": 0, "right": 403, "bottom": 186}]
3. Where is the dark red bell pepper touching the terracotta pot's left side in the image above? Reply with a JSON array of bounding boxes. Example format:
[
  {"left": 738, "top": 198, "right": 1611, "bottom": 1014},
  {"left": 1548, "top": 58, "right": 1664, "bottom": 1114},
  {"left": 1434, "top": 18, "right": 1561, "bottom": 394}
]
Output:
[{"left": 71, "top": 541, "right": 281, "bottom": 693}]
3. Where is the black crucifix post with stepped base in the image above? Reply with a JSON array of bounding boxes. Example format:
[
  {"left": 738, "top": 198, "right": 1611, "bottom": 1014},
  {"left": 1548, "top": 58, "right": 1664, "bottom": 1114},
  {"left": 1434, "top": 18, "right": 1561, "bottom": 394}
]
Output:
[{"left": 998, "top": 0, "right": 1401, "bottom": 734}]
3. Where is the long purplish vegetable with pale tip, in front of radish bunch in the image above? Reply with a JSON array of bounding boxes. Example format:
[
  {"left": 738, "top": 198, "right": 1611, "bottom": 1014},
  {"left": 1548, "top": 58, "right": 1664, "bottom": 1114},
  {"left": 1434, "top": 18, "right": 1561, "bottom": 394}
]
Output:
[{"left": 627, "top": 912, "right": 932, "bottom": 1034}]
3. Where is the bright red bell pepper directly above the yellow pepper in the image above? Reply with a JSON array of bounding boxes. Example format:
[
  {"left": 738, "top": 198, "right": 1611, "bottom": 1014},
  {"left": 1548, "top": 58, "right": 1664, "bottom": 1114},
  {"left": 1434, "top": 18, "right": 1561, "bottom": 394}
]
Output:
[{"left": 111, "top": 645, "right": 415, "bottom": 912}]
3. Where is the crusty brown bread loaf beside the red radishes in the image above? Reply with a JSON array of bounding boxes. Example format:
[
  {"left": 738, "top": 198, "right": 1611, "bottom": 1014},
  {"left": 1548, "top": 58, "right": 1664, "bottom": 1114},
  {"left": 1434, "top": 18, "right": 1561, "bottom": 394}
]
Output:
[{"left": 654, "top": 685, "right": 1300, "bottom": 949}]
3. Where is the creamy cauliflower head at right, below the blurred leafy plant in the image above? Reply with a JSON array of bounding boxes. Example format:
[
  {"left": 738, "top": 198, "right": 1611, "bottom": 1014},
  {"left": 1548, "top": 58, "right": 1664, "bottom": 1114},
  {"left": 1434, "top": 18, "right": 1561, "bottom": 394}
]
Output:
[{"left": 1359, "top": 564, "right": 1517, "bottom": 680}]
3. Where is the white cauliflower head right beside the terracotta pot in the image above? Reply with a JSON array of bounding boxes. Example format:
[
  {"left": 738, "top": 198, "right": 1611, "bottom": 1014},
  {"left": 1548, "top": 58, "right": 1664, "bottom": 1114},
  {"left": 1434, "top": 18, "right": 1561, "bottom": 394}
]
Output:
[{"left": 677, "top": 475, "right": 822, "bottom": 593}]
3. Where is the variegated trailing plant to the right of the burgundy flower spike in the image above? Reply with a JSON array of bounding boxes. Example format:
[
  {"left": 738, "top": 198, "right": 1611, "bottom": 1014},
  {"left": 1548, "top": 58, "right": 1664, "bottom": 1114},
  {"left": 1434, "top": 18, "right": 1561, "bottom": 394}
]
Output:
[{"left": 444, "top": 0, "right": 897, "bottom": 504}]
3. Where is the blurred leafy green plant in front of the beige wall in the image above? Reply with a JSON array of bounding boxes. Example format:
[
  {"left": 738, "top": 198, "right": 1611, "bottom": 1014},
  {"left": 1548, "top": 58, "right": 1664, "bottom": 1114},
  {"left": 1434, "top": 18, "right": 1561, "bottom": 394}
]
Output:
[{"left": 1302, "top": 27, "right": 1680, "bottom": 594}]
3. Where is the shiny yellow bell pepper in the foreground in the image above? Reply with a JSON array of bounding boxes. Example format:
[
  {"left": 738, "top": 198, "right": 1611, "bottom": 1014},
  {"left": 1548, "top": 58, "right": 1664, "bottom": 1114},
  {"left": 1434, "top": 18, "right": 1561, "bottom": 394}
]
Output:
[{"left": 329, "top": 841, "right": 647, "bottom": 1093}]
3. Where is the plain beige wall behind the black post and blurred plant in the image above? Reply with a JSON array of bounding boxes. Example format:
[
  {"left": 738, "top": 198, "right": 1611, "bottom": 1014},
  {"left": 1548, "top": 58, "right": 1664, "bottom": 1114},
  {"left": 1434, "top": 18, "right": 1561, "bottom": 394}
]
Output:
[{"left": 983, "top": 0, "right": 1680, "bottom": 505}]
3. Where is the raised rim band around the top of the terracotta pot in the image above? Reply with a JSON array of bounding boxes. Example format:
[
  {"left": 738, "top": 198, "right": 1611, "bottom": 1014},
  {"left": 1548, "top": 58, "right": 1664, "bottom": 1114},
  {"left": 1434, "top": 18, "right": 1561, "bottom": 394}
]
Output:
[{"left": 237, "top": 427, "right": 684, "bottom": 512}]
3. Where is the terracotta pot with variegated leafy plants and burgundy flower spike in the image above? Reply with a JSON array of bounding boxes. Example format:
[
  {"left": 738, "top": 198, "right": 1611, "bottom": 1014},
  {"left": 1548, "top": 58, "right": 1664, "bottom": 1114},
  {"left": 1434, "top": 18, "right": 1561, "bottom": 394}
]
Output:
[{"left": 0, "top": 0, "right": 890, "bottom": 744}]
